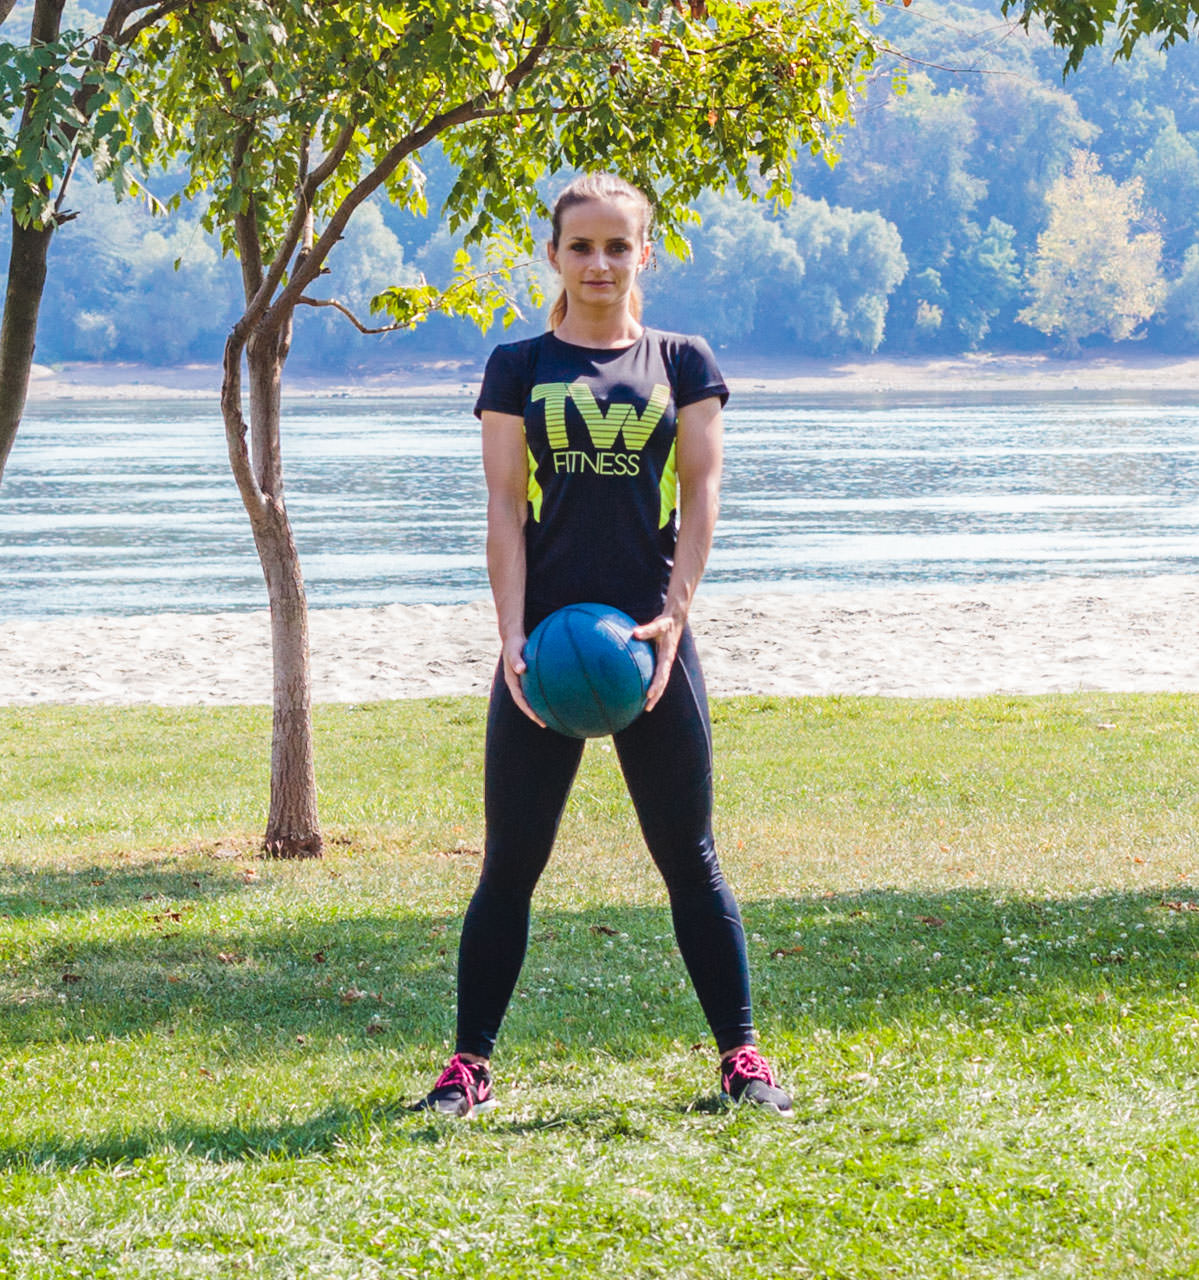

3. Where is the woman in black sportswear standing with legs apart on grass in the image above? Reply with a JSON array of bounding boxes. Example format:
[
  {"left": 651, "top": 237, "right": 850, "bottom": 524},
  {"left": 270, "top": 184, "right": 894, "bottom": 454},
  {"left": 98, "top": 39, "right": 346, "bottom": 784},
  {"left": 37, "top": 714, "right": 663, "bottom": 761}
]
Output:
[{"left": 417, "top": 174, "right": 793, "bottom": 1117}]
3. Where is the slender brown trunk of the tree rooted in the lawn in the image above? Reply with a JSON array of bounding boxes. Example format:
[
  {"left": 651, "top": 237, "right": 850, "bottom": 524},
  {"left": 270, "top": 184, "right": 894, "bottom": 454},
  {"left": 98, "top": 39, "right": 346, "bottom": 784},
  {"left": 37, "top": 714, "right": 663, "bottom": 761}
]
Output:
[{"left": 223, "top": 334, "right": 324, "bottom": 858}]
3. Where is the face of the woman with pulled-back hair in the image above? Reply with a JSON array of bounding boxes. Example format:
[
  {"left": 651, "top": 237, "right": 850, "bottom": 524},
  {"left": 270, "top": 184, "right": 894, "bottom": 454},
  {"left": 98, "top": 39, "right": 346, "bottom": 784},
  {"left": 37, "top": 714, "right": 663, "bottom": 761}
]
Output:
[{"left": 548, "top": 200, "right": 650, "bottom": 317}]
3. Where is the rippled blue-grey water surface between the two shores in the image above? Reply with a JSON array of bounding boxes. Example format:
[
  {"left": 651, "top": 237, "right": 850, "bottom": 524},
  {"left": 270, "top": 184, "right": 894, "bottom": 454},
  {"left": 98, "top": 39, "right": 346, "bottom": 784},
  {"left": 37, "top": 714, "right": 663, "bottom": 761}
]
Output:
[{"left": 0, "top": 396, "right": 1199, "bottom": 617}]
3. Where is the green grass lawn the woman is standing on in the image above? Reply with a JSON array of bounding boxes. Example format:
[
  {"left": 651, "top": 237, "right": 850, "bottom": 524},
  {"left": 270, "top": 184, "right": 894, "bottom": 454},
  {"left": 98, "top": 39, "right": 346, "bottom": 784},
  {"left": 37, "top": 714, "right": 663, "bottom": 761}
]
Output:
[{"left": 0, "top": 695, "right": 1199, "bottom": 1280}]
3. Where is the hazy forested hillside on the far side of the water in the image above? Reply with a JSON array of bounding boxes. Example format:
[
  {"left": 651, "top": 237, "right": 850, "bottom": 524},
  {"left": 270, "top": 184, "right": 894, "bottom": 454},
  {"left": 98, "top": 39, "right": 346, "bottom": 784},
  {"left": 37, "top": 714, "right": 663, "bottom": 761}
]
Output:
[{"left": 9, "top": 0, "right": 1199, "bottom": 369}]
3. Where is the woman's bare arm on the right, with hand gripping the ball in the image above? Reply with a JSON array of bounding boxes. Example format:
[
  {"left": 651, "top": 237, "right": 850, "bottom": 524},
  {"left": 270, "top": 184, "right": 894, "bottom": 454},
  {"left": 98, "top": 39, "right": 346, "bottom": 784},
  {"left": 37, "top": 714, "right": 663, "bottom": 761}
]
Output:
[{"left": 633, "top": 396, "right": 724, "bottom": 710}]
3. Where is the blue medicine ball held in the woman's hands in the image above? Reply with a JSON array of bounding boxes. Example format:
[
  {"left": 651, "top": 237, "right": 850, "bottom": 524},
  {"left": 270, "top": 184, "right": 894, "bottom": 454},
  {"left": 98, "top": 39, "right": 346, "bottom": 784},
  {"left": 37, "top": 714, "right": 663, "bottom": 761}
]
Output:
[{"left": 521, "top": 604, "right": 654, "bottom": 737}]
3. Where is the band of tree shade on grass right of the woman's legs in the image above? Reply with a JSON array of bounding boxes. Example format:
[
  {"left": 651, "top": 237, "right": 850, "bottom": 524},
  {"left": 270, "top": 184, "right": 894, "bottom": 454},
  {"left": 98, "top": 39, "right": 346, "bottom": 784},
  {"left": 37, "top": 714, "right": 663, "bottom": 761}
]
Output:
[{"left": 745, "top": 888, "right": 1199, "bottom": 1032}]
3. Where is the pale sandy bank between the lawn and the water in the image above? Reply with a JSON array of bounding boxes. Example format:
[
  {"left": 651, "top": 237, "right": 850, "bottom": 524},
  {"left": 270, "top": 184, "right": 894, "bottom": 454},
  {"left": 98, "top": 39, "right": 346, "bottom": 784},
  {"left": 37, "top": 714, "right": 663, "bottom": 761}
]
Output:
[{"left": 0, "top": 577, "right": 1199, "bottom": 705}]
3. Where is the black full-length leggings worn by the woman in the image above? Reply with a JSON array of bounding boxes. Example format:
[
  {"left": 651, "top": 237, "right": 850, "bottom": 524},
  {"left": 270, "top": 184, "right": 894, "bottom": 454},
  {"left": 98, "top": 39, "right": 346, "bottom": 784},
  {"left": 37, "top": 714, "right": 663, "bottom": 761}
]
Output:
[{"left": 457, "top": 631, "right": 755, "bottom": 1057}]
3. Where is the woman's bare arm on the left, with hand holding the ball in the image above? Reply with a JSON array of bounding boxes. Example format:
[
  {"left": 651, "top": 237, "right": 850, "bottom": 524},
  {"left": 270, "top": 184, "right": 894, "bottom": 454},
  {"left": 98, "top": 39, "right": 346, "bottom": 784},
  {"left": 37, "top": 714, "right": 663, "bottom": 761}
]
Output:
[{"left": 482, "top": 410, "right": 544, "bottom": 727}]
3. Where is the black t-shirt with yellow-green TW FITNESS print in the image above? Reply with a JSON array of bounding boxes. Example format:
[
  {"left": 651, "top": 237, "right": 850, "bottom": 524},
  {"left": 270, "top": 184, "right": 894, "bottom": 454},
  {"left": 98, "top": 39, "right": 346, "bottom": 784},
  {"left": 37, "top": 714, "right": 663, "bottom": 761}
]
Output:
[{"left": 475, "top": 329, "right": 728, "bottom": 627}]
